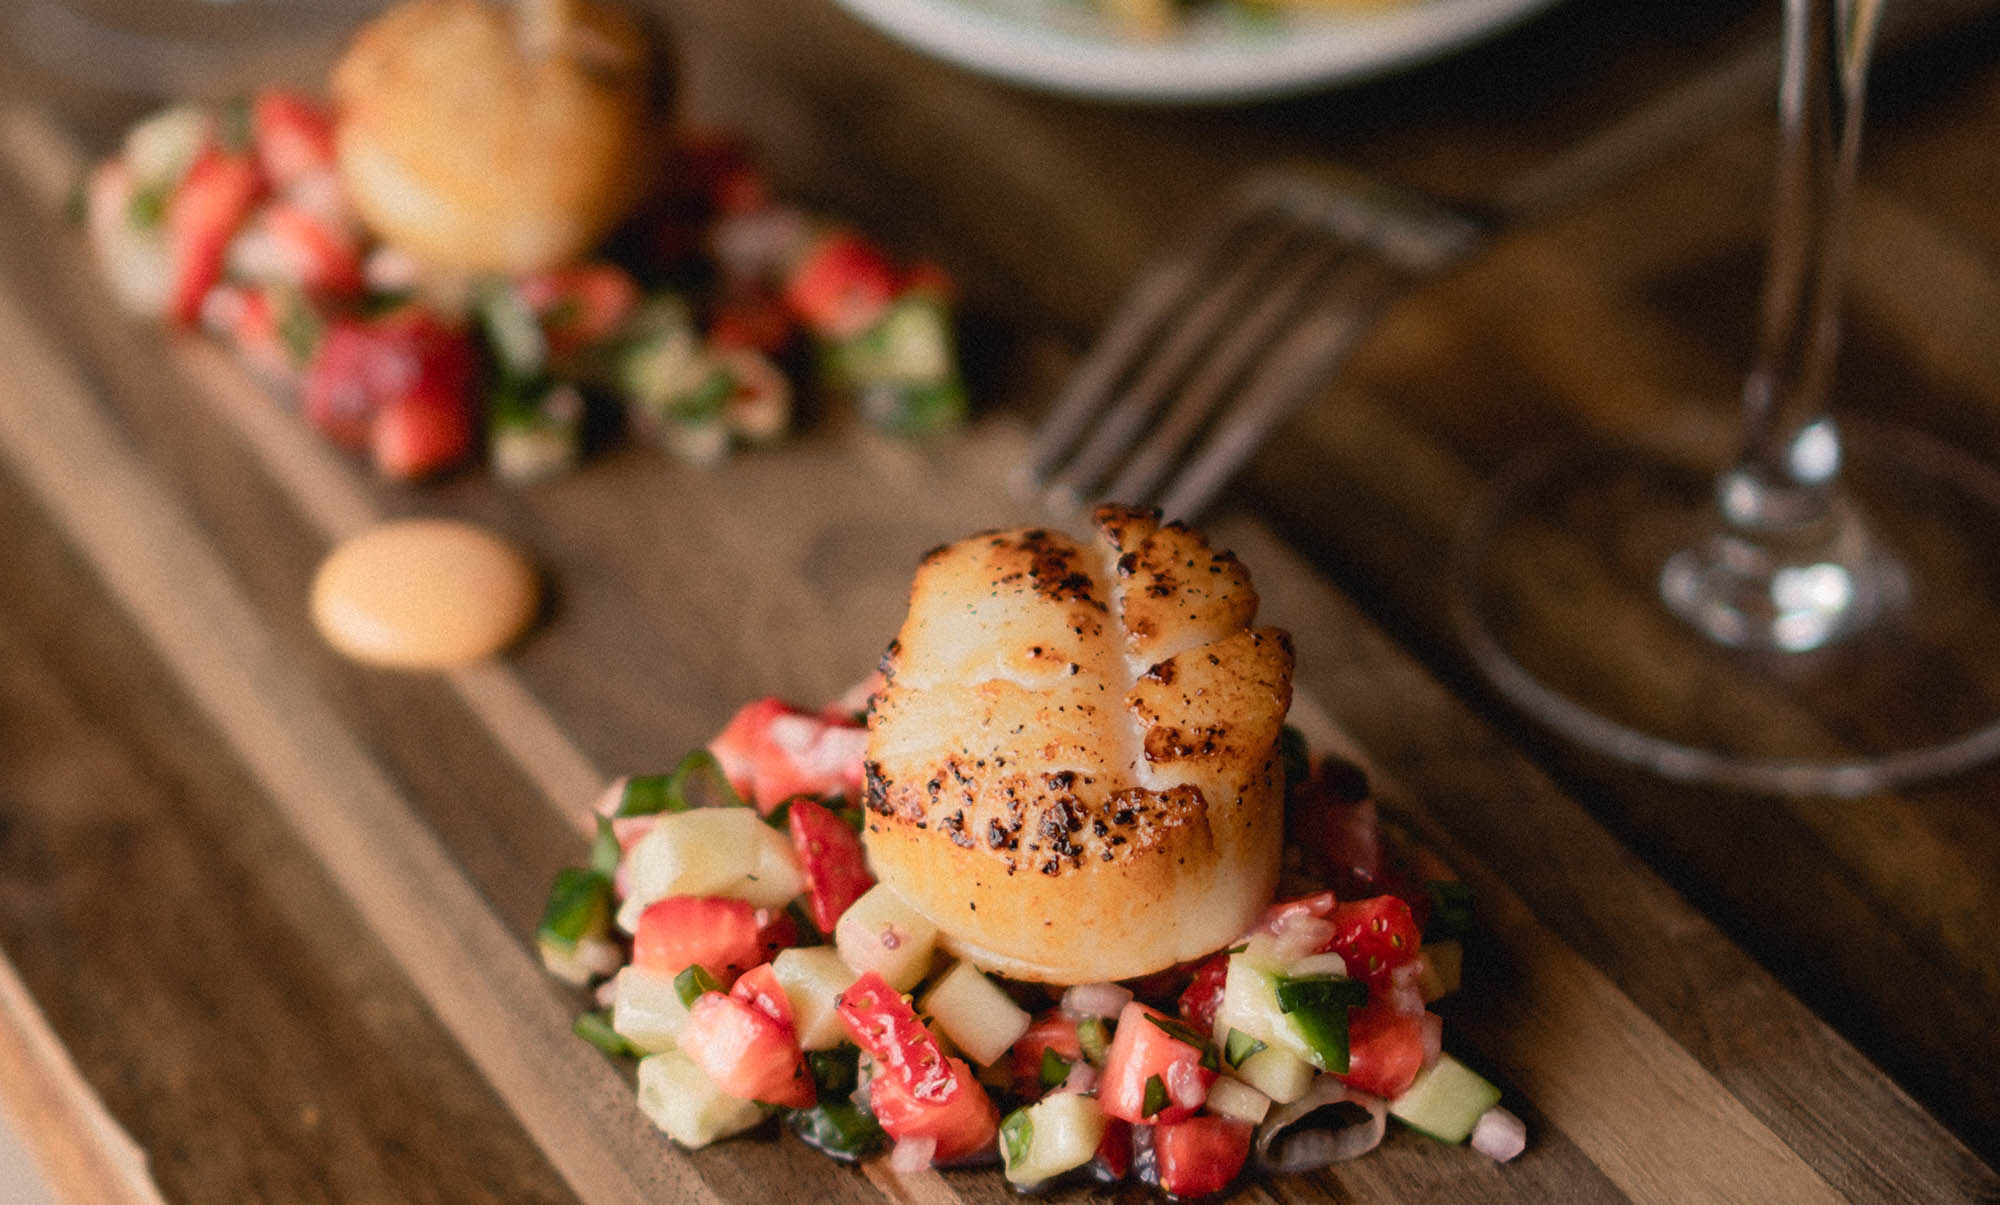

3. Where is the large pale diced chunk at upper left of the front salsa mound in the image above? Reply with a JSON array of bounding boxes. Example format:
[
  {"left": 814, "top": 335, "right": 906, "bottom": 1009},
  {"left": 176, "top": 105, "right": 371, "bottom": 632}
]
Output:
[{"left": 618, "top": 807, "right": 804, "bottom": 933}]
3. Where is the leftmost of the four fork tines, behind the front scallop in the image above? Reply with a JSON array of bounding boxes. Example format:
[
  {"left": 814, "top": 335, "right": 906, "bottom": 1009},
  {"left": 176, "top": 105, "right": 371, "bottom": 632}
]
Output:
[{"left": 1024, "top": 188, "right": 1254, "bottom": 486}]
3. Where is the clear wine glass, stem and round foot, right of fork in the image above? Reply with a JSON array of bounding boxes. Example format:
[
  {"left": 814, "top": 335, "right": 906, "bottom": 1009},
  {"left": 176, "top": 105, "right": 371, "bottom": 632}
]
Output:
[{"left": 1452, "top": 0, "right": 2000, "bottom": 797}]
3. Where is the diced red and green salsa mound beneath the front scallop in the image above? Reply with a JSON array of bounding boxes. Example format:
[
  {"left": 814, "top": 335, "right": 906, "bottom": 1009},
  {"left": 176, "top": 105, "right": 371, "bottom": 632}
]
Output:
[{"left": 540, "top": 699, "right": 1524, "bottom": 1197}]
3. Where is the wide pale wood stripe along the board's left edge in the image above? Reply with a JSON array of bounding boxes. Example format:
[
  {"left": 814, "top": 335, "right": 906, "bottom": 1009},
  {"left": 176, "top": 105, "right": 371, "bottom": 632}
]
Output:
[{"left": 0, "top": 286, "right": 712, "bottom": 1201}]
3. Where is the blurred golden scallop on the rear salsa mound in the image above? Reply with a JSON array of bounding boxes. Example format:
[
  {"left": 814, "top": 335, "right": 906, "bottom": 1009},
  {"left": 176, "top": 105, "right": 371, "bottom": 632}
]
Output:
[{"left": 332, "top": 0, "right": 664, "bottom": 272}]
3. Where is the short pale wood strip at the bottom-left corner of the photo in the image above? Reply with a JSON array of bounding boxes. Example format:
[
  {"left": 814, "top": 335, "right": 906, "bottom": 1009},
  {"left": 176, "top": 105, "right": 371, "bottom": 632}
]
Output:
[{"left": 0, "top": 953, "right": 164, "bottom": 1205}]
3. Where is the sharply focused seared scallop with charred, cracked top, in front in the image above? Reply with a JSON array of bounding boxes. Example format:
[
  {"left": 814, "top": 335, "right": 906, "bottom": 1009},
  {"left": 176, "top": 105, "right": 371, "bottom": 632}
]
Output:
[{"left": 864, "top": 506, "right": 1292, "bottom": 983}]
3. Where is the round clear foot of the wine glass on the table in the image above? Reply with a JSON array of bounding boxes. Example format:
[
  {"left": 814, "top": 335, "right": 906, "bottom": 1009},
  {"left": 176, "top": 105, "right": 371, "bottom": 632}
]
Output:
[{"left": 1450, "top": 422, "right": 2000, "bottom": 797}]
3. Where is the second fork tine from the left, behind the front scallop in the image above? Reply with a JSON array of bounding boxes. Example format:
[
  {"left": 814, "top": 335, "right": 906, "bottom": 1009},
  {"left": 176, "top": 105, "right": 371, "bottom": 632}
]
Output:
[{"left": 1048, "top": 222, "right": 1296, "bottom": 508}]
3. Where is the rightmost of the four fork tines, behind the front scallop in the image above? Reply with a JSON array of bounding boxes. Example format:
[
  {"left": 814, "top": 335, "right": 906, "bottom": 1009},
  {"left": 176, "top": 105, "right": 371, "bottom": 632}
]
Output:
[{"left": 1160, "top": 256, "right": 1408, "bottom": 518}]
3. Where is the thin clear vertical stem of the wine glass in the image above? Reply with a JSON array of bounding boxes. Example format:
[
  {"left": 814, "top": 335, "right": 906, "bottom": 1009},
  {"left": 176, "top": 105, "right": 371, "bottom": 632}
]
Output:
[{"left": 1718, "top": 0, "right": 1882, "bottom": 538}]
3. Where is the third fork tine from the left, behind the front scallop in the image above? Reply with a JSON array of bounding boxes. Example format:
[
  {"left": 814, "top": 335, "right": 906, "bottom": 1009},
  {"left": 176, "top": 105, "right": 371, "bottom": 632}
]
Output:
[{"left": 1104, "top": 232, "right": 1342, "bottom": 506}]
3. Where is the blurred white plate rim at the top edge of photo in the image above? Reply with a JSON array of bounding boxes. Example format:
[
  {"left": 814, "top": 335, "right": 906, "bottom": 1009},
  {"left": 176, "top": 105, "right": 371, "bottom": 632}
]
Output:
[{"left": 838, "top": 0, "right": 1552, "bottom": 102}]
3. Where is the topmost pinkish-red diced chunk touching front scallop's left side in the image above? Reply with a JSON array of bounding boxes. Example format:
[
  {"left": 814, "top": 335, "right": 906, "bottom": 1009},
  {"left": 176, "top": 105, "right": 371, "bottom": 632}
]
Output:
[{"left": 708, "top": 699, "right": 868, "bottom": 815}]
